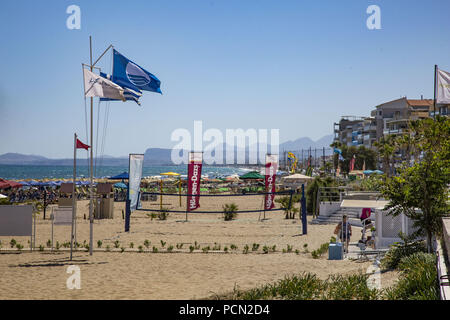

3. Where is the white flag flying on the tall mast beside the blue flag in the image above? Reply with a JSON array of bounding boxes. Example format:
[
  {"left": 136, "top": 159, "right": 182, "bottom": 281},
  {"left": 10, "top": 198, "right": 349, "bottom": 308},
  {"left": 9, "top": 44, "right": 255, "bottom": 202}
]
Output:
[{"left": 83, "top": 69, "right": 125, "bottom": 101}]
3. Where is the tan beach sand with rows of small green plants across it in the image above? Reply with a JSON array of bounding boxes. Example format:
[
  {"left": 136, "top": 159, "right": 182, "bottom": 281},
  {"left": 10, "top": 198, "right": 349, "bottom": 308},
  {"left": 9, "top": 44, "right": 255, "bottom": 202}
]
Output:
[{"left": 0, "top": 196, "right": 370, "bottom": 299}]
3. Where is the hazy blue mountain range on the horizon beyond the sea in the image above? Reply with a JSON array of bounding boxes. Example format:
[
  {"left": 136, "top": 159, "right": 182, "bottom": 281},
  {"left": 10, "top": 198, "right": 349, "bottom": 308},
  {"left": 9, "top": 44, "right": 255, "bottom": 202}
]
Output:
[{"left": 0, "top": 135, "right": 333, "bottom": 166}]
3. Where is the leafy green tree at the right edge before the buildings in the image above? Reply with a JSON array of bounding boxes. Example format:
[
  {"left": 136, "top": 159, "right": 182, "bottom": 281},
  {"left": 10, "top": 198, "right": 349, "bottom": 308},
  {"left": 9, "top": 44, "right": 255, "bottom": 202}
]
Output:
[{"left": 381, "top": 116, "right": 450, "bottom": 252}]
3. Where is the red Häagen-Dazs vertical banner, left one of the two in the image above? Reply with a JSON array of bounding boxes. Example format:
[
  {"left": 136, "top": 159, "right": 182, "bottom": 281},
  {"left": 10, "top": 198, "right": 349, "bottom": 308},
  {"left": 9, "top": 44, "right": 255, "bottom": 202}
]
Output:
[{"left": 187, "top": 152, "right": 203, "bottom": 211}]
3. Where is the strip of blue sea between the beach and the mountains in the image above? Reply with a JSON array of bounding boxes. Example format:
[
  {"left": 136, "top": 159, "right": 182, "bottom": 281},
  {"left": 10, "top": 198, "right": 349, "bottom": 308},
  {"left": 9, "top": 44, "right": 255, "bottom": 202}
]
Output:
[{"left": 0, "top": 165, "right": 257, "bottom": 180}]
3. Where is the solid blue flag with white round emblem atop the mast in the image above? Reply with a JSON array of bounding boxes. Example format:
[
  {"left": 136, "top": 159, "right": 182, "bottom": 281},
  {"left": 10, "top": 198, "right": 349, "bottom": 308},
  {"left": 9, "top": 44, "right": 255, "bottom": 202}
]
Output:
[{"left": 111, "top": 49, "right": 162, "bottom": 94}]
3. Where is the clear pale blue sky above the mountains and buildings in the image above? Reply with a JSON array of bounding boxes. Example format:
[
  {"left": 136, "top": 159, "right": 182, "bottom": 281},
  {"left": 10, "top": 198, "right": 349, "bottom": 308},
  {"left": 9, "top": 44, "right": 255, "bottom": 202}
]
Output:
[{"left": 0, "top": 0, "right": 450, "bottom": 158}]
